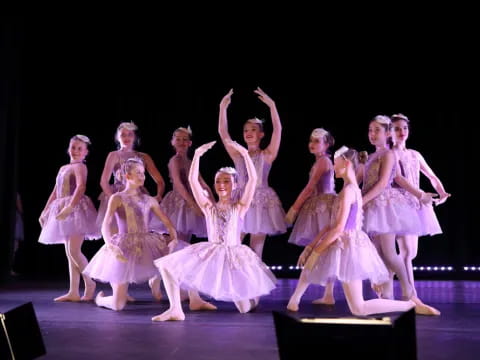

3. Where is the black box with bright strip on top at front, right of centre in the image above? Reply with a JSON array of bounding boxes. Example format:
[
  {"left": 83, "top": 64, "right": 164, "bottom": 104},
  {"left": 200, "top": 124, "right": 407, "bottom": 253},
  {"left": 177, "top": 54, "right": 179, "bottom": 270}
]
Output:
[{"left": 273, "top": 309, "right": 417, "bottom": 360}]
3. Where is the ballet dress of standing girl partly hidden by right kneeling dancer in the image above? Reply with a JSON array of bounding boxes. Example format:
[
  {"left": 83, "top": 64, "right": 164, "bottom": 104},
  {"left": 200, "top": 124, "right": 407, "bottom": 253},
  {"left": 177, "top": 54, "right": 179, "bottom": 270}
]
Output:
[{"left": 288, "top": 159, "right": 336, "bottom": 246}]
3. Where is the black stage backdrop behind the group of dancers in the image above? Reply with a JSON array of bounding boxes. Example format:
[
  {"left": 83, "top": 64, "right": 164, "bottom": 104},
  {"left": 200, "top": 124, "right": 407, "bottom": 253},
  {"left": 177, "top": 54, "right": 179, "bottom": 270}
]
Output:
[{"left": 0, "top": 18, "right": 480, "bottom": 278}]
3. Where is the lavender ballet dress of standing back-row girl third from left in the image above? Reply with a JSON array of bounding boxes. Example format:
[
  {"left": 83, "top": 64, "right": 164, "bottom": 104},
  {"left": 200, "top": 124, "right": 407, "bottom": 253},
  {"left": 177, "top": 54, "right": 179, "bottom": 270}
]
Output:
[{"left": 150, "top": 155, "right": 207, "bottom": 237}]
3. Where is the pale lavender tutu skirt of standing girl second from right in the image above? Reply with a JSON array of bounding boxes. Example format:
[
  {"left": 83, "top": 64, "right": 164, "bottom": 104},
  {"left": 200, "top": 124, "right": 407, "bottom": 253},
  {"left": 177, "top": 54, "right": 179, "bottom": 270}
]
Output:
[{"left": 363, "top": 188, "right": 422, "bottom": 235}]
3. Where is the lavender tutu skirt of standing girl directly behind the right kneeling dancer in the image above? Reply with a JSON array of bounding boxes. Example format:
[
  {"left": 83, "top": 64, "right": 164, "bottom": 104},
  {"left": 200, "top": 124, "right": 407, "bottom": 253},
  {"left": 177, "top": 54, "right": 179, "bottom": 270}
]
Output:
[{"left": 288, "top": 194, "right": 336, "bottom": 246}]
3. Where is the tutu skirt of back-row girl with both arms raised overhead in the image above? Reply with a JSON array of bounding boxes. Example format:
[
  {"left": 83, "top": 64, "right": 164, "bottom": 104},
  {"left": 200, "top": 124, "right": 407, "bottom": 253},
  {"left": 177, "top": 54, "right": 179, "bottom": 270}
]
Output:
[{"left": 242, "top": 187, "right": 287, "bottom": 235}]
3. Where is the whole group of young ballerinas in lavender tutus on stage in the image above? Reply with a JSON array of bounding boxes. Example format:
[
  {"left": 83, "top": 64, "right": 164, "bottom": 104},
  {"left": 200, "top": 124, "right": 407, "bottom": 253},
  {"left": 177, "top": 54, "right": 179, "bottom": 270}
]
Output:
[{"left": 39, "top": 88, "right": 450, "bottom": 321}]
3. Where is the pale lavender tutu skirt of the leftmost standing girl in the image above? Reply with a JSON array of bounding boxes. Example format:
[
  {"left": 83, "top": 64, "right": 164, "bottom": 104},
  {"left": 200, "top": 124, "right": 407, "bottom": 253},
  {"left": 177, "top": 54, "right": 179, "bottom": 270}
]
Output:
[{"left": 38, "top": 195, "right": 102, "bottom": 245}]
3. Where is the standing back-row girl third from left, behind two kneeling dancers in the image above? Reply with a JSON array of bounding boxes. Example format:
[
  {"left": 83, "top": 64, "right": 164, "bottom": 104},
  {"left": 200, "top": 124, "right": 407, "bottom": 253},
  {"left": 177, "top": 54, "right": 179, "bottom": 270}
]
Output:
[{"left": 150, "top": 126, "right": 213, "bottom": 245}]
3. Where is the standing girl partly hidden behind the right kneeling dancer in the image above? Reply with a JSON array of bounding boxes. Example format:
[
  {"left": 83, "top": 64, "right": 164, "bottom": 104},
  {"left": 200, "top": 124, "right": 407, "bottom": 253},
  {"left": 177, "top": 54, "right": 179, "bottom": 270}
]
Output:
[{"left": 285, "top": 128, "right": 336, "bottom": 305}]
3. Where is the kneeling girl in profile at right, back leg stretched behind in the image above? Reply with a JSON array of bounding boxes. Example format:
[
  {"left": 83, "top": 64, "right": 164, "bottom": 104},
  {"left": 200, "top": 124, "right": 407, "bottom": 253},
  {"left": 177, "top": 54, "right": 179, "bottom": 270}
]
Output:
[{"left": 287, "top": 147, "right": 440, "bottom": 316}]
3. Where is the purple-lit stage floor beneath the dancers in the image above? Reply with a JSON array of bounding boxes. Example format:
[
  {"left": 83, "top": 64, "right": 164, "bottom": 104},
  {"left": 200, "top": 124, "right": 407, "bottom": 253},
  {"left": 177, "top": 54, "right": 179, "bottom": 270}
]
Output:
[{"left": 0, "top": 279, "right": 480, "bottom": 360}]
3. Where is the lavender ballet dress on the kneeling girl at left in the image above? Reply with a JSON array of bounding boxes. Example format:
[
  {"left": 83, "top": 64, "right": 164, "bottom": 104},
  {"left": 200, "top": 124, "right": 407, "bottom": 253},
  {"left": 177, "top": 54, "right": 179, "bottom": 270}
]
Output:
[{"left": 83, "top": 193, "right": 169, "bottom": 284}]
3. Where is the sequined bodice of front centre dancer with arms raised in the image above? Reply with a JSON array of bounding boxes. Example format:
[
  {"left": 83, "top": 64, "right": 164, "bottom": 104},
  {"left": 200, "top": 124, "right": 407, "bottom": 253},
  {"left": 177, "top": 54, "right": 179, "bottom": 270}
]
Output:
[{"left": 206, "top": 204, "right": 242, "bottom": 246}]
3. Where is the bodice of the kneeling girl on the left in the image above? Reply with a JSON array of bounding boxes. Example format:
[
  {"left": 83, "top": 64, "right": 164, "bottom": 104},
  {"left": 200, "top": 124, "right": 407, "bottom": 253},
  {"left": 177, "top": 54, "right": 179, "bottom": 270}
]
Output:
[{"left": 115, "top": 193, "right": 152, "bottom": 234}]
